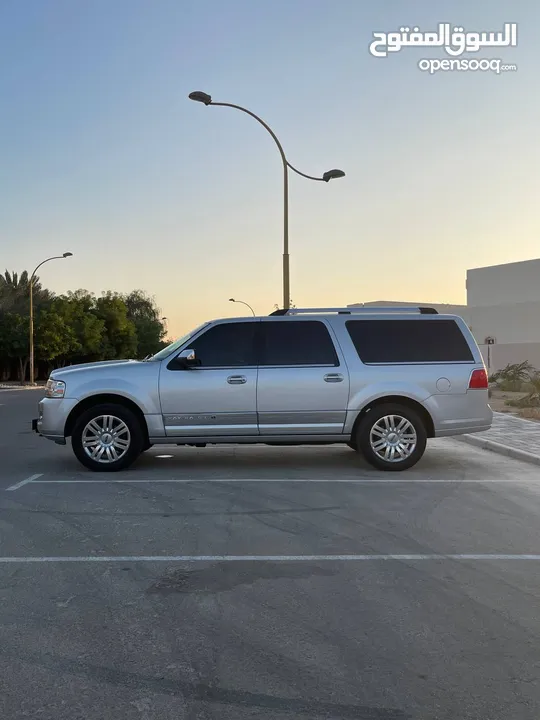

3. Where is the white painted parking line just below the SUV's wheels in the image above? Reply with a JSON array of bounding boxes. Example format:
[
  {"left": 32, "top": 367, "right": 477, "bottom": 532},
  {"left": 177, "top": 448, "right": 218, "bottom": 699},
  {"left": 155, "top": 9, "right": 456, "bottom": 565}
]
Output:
[{"left": 28, "top": 475, "right": 528, "bottom": 490}]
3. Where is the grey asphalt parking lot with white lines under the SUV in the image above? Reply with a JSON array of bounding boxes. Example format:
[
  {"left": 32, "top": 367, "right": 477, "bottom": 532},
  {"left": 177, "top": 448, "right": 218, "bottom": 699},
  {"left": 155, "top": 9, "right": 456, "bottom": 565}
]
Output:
[{"left": 0, "top": 390, "right": 540, "bottom": 720}]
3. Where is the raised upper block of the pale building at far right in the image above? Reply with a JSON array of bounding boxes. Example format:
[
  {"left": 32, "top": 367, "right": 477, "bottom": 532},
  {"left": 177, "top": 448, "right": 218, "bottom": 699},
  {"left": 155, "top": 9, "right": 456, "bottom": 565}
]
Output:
[{"left": 467, "top": 259, "right": 540, "bottom": 307}]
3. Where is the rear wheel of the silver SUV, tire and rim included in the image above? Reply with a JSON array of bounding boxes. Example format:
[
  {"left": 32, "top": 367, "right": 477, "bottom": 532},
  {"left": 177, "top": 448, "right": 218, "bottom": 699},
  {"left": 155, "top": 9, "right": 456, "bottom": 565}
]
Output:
[{"left": 357, "top": 403, "right": 427, "bottom": 472}]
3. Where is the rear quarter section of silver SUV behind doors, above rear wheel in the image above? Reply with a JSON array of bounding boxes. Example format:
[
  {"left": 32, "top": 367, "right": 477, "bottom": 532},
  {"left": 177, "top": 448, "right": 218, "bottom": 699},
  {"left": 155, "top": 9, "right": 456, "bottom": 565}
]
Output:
[{"left": 338, "top": 314, "right": 491, "bottom": 435}]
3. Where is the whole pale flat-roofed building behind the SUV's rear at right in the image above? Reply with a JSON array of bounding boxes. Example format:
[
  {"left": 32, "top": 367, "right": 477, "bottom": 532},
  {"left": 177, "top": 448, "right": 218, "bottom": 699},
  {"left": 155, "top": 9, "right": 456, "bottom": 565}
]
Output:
[{"left": 349, "top": 259, "right": 540, "bottom": 372}]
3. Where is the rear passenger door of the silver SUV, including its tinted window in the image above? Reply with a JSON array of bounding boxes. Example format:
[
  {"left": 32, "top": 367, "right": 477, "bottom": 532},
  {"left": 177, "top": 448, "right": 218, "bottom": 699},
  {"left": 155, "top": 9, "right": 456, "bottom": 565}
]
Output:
[{"left": 257, "top": 317, "right": 349, "bottom": 436}]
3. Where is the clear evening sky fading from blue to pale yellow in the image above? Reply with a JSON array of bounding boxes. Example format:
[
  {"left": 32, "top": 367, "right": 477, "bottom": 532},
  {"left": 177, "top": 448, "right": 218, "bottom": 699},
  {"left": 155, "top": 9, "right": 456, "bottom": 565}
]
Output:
[{"left": 0, "top": 0, "right": 540, "bottom": 336}]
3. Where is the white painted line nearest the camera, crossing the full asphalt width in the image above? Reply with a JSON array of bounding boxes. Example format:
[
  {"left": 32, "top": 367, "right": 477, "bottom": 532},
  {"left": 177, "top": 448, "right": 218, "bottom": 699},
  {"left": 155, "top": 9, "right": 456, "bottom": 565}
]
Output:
[{"left": 0, "top": 553, "right": 540, "bottom": 564}]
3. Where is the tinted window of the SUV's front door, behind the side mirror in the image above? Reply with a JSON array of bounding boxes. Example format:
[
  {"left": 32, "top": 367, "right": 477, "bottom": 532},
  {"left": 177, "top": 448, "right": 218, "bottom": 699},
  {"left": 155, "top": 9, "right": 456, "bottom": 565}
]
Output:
[{"left": 189, "top": 322, "right": 258, "bottom": 367}]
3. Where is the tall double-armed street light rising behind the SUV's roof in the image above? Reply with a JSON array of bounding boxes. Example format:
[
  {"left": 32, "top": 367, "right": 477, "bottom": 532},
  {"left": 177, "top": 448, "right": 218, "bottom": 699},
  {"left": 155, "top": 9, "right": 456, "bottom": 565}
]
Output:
[{"left": 189, "top": 90, "right": 345, "bottom": 309}]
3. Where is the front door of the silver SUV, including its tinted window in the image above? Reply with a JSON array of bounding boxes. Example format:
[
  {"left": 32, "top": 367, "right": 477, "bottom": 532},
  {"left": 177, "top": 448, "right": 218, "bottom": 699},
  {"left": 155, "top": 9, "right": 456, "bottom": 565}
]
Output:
[{"left": 159, "top": 320, "right": 259, "bottom": 438}]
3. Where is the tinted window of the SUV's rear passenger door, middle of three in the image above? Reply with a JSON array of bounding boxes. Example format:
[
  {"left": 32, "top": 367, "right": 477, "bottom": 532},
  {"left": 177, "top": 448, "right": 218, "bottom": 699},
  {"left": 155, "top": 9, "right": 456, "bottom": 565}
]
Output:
[{"left": 260, "top": 320, "right": 339, "bottom": 365}]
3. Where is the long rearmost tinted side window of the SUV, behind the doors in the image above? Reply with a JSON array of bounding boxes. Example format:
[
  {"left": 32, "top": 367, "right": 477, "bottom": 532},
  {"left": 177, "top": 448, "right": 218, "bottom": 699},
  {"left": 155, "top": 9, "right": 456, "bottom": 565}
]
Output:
[{"left": 346, "top": 320, "right": 474, "bottom": 363}]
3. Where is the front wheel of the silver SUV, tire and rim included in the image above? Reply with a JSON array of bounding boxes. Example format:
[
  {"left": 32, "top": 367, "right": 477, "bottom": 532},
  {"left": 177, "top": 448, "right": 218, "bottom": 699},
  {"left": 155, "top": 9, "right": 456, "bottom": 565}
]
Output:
[{"left": 71, "top": 403, "right": 145, "bottom": 472}]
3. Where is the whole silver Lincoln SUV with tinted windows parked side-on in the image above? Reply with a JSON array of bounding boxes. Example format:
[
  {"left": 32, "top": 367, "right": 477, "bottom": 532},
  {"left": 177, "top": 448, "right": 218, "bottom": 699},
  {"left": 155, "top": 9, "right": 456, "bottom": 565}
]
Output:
[{"left": 33, "top": 307, "right": 493, "bottom": 472}]
